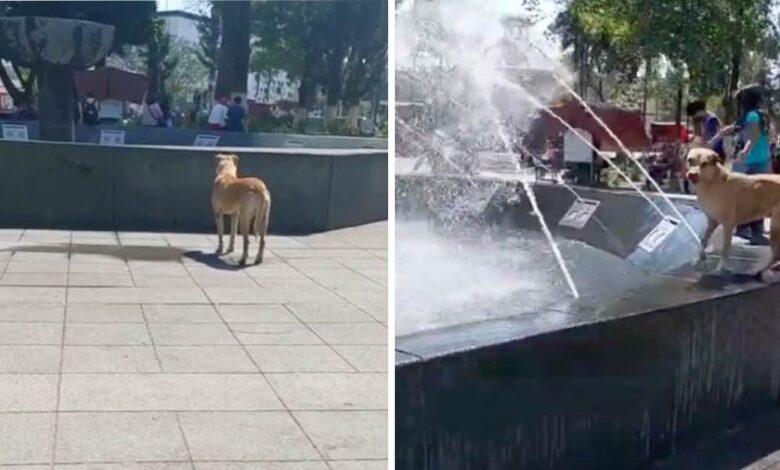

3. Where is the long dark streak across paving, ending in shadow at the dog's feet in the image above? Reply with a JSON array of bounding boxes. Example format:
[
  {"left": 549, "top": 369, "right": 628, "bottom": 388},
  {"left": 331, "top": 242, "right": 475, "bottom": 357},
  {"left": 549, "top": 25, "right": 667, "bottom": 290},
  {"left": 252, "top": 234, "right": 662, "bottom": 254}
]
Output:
[{"left": 0, "top": 244, "right": 246, "bottom": 271}]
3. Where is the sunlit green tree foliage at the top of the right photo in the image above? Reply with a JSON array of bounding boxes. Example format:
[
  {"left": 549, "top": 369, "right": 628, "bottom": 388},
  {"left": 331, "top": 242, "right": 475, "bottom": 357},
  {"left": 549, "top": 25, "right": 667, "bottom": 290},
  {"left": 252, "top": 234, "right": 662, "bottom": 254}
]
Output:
[{"left": 551, "top": 0, "right": 777, "bottom": 118}]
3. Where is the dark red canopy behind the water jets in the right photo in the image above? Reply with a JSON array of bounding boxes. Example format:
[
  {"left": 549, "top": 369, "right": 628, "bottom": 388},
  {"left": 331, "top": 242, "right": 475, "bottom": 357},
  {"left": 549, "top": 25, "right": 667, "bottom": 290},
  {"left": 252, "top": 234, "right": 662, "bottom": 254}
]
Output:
[{"left": 532, "top": 100, "right": 650, "bottom": 152}]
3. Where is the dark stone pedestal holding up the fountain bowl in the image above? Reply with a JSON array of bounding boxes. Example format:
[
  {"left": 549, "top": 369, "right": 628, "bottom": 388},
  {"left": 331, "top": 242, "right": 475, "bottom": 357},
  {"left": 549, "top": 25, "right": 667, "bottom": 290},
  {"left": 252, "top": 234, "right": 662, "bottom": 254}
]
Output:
[{"left": 38, "top": 66, "right": 76, "bottom": 142}]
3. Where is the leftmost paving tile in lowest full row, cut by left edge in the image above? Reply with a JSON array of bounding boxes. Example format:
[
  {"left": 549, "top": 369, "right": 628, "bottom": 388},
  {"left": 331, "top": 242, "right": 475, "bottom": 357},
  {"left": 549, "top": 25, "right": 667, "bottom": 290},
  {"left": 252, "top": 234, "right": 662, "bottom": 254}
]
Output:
[{"left": 0, "top": 413, "right": 54, "bottom": 465}]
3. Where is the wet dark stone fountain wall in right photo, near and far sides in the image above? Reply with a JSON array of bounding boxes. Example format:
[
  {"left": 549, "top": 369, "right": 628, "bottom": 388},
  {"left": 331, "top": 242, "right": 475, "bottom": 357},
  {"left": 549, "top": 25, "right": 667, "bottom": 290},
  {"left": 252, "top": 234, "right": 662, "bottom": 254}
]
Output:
[{"left": 395, "top": 174, "right": 780, "bottom": 470}]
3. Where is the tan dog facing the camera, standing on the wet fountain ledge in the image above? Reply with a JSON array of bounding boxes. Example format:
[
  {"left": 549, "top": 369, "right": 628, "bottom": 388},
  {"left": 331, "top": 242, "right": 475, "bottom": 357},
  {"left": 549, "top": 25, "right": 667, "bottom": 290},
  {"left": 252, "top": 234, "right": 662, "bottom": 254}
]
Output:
[{"left": 685, "top": 148, "right": 780, "bottom": 271}]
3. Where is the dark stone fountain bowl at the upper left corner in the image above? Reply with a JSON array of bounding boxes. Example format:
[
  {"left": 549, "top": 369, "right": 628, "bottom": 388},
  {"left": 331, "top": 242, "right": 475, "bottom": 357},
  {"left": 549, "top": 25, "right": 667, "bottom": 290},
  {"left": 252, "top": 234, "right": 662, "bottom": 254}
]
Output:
[{"left": 0, "top": 16, "right": 114, "bottom": 69}]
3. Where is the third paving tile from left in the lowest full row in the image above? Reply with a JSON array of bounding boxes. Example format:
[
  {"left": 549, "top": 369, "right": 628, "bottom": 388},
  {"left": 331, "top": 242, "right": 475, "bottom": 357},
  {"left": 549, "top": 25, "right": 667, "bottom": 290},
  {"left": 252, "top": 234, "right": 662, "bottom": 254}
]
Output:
[{"left": 179, "top": 412, "right": 320, "bottom": 460}]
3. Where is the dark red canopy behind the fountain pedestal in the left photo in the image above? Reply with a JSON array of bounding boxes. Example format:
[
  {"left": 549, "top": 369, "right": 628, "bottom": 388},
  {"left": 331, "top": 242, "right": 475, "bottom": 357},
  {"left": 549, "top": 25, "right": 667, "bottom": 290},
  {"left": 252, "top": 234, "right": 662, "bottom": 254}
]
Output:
[{"left": 73, "top": 67, "right": 149, "bottom": 103}]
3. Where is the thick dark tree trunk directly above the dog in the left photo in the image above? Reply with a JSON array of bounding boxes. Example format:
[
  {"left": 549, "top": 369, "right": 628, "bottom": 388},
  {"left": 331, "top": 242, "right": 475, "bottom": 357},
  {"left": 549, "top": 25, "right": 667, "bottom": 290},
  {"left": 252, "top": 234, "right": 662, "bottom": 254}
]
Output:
[{"left": 215, "top": 0, "right": 251, "bottom": 98}]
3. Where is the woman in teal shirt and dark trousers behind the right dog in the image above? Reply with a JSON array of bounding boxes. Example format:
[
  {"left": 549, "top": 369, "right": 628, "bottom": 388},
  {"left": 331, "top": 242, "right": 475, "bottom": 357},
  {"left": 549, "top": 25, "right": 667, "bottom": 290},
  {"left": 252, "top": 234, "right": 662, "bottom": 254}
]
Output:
[{"left": 736, "top": 87, "right": 772, "bottom": 245}]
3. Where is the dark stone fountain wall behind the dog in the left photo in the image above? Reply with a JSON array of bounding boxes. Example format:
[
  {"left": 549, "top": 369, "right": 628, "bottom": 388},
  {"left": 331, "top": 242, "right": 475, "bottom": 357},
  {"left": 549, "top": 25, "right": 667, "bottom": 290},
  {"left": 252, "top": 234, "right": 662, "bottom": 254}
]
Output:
[{"left": 0, "top": 140, "right": 388, "bottom": 233}]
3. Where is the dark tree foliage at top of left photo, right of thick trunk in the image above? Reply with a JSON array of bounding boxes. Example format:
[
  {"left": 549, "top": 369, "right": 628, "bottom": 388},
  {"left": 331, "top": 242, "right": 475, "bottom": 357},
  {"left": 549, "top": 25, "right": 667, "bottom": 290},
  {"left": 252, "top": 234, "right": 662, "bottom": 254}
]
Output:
[{"left": 250, "top": 1, "right": 388, "bottom": 117}]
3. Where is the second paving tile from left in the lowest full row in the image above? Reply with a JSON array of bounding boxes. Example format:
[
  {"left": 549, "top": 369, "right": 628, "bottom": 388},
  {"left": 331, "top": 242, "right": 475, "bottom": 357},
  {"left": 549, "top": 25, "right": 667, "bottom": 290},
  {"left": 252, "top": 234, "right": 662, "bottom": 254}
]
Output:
[{"left": 55, "top": 412, "right": 188, "bottom": 463}]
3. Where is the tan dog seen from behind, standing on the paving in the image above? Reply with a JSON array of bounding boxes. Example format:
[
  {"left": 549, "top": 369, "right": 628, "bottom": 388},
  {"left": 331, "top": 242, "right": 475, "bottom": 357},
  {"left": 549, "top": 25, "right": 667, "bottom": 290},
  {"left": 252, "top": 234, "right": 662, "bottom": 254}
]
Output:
[{"left": 211, "top": 154, "right": 271, "bottom": 265}]
